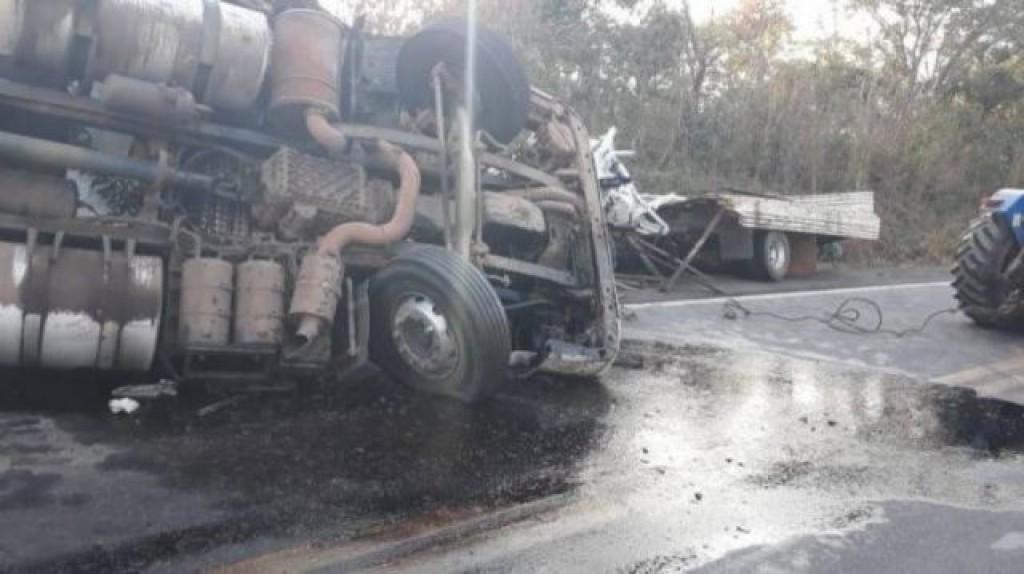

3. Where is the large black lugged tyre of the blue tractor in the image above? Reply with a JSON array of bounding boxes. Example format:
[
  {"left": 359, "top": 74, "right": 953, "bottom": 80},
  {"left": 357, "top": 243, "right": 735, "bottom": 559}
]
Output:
[{"left": 952, "top": 217, "right": 1024, "bottom": 330}]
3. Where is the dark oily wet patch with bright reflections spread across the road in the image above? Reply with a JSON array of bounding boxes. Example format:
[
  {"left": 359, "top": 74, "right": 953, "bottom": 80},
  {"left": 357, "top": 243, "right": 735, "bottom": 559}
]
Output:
[{"left": 6, "top": 337, "right": 1024, "bottom": 572}]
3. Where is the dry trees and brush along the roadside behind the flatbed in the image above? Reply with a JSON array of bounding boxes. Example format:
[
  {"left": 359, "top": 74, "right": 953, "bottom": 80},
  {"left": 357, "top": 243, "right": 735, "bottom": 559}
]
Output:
[{"left": 360, "top": 0, "right": 1024, "bottom": 262}]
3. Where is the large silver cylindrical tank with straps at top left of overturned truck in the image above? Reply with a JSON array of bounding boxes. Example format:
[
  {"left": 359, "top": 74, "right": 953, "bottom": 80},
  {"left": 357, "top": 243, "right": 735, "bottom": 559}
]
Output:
[{"left": 0, "top": 0, "right": 270, "bottom": 111}]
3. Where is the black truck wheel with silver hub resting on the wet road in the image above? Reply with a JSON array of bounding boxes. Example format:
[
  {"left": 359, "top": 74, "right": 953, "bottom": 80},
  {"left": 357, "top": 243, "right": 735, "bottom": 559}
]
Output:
[{"left": 370, "top": 246, "right": 511, "bottom": 402}]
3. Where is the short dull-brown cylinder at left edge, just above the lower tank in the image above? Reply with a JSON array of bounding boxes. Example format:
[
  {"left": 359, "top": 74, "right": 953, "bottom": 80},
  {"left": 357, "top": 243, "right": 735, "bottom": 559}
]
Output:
[{"left": 0, "top": 169, "right": 78, "bottom": 219}]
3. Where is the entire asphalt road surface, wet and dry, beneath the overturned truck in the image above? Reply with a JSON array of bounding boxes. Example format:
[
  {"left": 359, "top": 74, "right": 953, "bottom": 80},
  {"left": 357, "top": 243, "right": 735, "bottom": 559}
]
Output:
[{"left": 6, "top": 269, "right": 1024, "bottom": 573}]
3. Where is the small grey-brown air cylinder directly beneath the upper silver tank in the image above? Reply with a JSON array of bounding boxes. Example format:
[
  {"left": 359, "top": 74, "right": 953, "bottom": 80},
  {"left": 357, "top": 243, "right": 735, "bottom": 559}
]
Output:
[{"left": 96, "top": 76, "right": 200, "bottom": 125}]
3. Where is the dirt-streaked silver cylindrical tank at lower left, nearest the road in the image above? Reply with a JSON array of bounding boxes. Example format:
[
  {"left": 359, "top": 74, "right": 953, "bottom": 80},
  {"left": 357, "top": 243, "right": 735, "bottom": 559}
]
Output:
[{"left": 0, "top": 241, "right": 164, "bottom": 372}]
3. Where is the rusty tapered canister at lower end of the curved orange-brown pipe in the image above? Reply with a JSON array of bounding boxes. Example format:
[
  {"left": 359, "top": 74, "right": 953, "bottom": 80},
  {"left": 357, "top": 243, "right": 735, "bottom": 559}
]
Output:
[{"left": 288, "top": 253, "right": 344, "bottom": 343}]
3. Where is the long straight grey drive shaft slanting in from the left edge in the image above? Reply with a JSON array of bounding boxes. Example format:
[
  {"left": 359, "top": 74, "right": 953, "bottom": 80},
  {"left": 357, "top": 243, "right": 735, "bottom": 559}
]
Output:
[{"left": 0, "top": 132, "right": 216, "bottom": 191}]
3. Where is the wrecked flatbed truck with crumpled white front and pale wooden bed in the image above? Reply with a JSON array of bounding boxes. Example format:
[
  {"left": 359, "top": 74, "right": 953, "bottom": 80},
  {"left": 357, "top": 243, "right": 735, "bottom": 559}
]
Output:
[{"left": 592, "top": 128, "right": 882, "bottom": 282}]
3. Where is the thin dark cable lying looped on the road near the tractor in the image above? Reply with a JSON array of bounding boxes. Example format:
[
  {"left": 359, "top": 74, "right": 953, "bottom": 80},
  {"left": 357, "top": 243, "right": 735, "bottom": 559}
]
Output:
[{"left": 722, "top": 297, "right": 959, "bottom": 339}]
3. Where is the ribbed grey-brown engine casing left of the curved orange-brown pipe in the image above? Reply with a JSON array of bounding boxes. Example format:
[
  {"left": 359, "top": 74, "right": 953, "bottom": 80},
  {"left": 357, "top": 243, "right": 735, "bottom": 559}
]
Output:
[{"left": 257, "top": 147, "right": 394, "bottom": 238}]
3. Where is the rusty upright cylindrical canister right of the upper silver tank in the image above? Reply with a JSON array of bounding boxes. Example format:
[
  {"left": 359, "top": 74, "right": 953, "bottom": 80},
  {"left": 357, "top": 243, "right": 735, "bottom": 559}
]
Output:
[{"left": 269, "top": 9, "right": 345, "bottom": 132}]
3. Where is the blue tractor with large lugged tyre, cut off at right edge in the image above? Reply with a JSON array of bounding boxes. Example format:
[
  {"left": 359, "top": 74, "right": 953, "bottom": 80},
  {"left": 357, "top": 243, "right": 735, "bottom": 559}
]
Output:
[{"left": 953, "top": 189, "right": 1024, "bottom": 330}]
